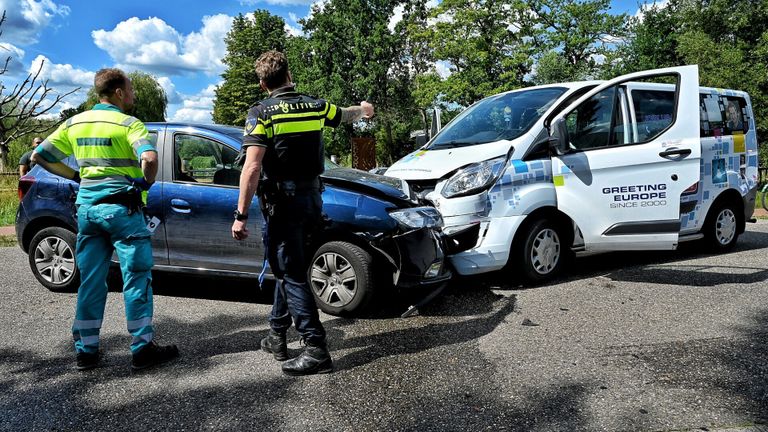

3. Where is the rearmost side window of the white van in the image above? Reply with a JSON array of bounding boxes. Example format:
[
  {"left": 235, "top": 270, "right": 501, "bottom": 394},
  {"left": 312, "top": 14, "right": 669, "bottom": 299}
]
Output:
[{"left": 699, "top": 94, "right": 749, "bottom": 137}]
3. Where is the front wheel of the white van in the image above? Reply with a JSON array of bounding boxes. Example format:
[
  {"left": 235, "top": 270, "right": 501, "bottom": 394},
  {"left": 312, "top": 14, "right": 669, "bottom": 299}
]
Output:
[{"left": 510, "top": 218, "right": 570, "bottom": 284}]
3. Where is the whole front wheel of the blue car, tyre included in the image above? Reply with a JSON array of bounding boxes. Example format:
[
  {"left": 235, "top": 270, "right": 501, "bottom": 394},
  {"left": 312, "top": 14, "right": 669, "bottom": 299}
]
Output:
[{"left": 309, "top": 241, "right": 375, "bottom": 315}]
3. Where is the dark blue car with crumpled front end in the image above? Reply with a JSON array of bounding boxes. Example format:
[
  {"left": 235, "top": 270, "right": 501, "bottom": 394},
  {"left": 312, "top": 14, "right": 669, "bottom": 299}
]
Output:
[{"left": 16, "top": 123, "right": 457, "bottom": 315}]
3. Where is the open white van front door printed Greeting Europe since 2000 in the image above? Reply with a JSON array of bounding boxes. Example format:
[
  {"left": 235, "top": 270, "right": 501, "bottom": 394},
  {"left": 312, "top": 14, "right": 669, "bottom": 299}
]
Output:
[{"left": 552, "top": 66, "right": 701, "bottom": 250}]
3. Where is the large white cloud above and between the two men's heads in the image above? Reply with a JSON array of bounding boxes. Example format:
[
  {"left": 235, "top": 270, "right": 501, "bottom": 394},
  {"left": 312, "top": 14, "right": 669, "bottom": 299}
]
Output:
[{"left": 91, "top": 14, "right": 232, "bottom": 75}]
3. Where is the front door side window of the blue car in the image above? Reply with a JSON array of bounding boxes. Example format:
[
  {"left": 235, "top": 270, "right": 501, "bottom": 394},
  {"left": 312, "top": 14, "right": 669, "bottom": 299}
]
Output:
[{"left": 173, "top": 134, "right": 240, "bottom": 186}]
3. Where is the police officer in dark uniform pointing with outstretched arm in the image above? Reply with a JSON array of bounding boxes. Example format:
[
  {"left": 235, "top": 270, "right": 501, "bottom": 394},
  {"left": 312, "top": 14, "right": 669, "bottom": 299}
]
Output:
[{"left": 232, "top": 51, "right": 373, "bottom": 375}]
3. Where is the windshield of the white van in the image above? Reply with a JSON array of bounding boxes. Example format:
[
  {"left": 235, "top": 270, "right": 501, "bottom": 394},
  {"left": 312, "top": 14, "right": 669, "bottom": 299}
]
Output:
[{"left": 429, "top": 87, "right": 566, "bottom": 149}]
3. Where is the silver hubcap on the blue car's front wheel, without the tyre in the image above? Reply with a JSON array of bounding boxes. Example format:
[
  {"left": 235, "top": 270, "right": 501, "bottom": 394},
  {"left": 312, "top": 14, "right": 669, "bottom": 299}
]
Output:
[{"left": 311, "top": 252, "right": 357, "bottom": 307}]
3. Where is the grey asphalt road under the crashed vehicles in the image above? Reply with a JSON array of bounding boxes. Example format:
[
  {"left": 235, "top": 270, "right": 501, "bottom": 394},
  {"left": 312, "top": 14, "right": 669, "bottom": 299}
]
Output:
[{"left": 0, "top": 220, "right": 768, "bottom": 431}]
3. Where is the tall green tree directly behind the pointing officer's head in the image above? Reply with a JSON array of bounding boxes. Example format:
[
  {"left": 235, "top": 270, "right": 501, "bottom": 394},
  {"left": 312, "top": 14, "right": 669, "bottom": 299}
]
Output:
[{"left": 213, "top": 10, "right": 286, "bottom": 126}]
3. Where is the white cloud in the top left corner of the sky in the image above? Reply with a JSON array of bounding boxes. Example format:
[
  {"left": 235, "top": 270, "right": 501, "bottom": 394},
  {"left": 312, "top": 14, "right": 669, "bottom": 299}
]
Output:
[{"left": 0, "top": 0, "right": 69, "bottom": 46}]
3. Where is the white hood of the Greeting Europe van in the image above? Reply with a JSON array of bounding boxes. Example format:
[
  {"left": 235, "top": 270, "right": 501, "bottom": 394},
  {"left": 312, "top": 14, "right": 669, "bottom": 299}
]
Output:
[{"left": 386, "top": 140, "right": 513, "bottom": 180}]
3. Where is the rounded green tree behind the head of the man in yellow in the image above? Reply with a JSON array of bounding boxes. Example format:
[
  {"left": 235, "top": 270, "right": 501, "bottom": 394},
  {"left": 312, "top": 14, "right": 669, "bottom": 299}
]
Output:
[{"left": 82, "top": 71, "right": 168, "bottom": 122}]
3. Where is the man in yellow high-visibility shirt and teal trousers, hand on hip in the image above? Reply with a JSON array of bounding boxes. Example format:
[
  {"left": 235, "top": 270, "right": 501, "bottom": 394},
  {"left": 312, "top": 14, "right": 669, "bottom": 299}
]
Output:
[{"left": 32, "top": 69, "right": 179, "bottom": 370}]
